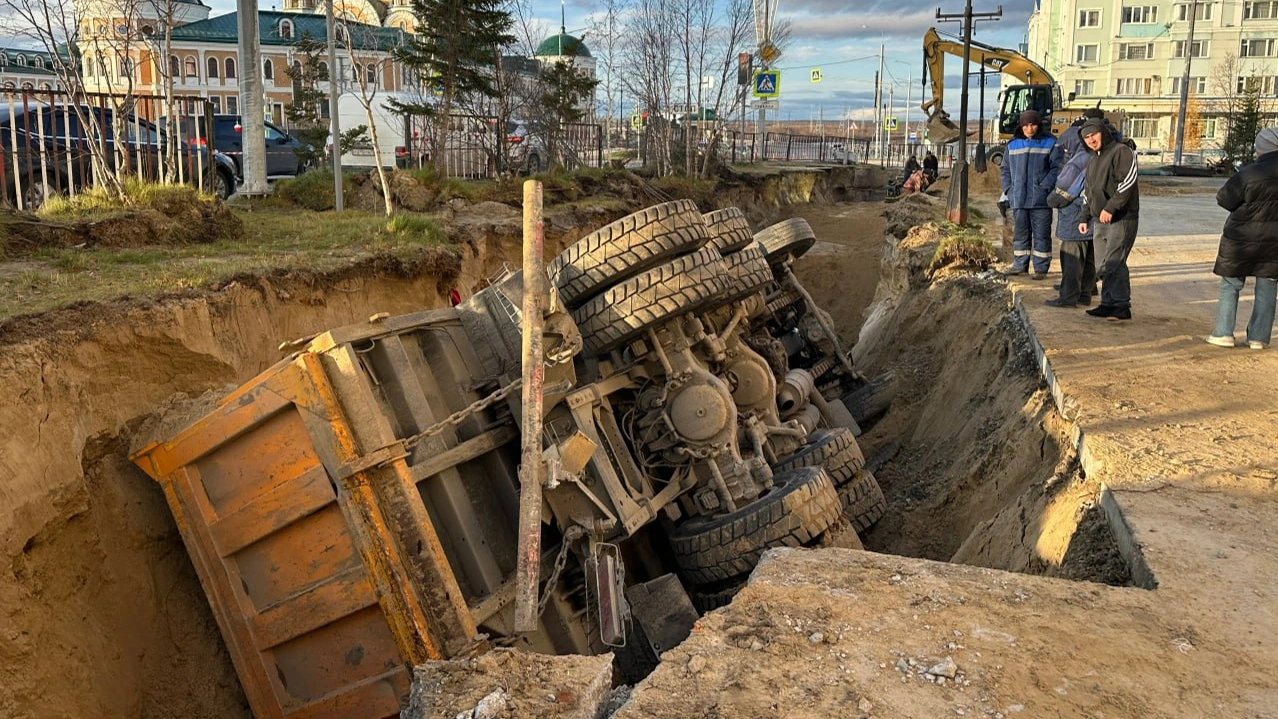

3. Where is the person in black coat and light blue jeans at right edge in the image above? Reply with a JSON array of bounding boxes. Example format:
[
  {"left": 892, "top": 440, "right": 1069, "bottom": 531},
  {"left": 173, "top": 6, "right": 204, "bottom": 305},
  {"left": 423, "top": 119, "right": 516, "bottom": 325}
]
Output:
[{"left": 1206, "top": 128, "right": 1278, "bottom": 350}]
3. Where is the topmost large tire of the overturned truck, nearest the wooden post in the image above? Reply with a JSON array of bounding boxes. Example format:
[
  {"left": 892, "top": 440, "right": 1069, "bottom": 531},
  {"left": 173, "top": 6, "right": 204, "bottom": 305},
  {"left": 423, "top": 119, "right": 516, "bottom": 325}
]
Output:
[{"left": 546, "top": 199, "right": 709, "bottom": 309}]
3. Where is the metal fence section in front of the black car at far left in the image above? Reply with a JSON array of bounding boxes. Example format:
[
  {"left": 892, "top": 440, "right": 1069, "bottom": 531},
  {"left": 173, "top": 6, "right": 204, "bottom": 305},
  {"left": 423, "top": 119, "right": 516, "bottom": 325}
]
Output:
[{"left": 0, "top": 89, "right": 213, "bottom": 209}]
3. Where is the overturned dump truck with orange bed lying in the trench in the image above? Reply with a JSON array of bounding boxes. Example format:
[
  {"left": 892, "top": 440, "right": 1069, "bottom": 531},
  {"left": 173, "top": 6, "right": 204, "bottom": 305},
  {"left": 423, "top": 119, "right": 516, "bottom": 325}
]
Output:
[{"left": 133, "top": 201, "right": 884, "bottom": 718}]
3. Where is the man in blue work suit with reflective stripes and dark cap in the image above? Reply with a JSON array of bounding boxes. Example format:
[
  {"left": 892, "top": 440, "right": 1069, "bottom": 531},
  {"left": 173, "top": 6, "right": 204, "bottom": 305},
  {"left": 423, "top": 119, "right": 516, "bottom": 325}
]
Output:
[{"left": 999, "top": 110, "right": 1061, "bottom": 280}]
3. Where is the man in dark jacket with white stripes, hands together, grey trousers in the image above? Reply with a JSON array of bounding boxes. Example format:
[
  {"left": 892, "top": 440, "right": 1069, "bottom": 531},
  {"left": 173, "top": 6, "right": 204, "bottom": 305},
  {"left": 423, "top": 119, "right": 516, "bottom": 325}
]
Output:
[{"left": 1079, "top": 117, "right": 1140, "bottom": 319}]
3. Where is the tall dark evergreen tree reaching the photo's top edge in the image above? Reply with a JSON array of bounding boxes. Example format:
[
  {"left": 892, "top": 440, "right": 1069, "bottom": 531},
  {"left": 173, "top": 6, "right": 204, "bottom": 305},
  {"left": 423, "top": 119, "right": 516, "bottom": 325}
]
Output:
[{"left": 395, "top": 0, "right": 515, "bottom": 164}]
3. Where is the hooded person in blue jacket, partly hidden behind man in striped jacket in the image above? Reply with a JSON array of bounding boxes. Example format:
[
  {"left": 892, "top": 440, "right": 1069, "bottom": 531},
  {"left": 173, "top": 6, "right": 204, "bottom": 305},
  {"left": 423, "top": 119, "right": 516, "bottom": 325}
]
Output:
[{"left": 1044, "top": 109, "right": 1103, "bottom": 308}]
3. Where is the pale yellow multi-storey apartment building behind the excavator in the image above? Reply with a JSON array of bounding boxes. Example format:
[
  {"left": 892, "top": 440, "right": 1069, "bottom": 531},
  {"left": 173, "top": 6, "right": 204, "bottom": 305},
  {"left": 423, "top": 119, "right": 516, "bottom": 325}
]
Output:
[{"left": 1026, "top": 0, "right": 1278, "bottom": 156}]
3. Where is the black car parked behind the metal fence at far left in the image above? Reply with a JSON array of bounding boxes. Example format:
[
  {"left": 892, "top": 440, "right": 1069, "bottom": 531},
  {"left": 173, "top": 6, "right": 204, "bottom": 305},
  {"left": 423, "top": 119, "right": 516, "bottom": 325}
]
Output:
[{"left": 0, "top": 100, "right": 236, "bottom": 211}]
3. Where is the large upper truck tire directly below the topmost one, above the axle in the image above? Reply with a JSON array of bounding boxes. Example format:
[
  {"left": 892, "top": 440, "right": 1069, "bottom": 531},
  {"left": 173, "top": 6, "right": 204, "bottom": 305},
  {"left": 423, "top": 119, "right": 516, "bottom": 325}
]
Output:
[{"left": 573, "top": 248, "right": 728, "bottom": 355}]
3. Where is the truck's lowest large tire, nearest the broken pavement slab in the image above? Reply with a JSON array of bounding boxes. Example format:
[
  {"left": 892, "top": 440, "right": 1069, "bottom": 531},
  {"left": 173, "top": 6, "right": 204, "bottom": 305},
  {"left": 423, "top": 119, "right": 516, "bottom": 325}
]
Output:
[{"left": 670, "top": 467, "right": 842, "bottom": 585}]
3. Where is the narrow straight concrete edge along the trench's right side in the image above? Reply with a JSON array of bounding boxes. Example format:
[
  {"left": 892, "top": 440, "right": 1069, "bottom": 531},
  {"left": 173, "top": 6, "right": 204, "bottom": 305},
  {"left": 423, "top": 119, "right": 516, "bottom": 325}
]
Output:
[{"left": 1011, "top": 287, "right": 1158, "bottom": 589}]
